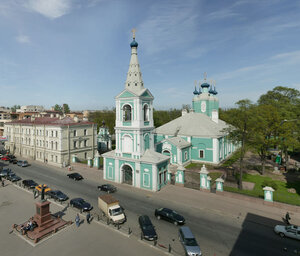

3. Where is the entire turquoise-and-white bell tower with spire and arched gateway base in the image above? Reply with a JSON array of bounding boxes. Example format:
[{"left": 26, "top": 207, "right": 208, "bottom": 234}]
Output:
[{"left": 102, "top": 32, "right": 169, "bottom": 191}]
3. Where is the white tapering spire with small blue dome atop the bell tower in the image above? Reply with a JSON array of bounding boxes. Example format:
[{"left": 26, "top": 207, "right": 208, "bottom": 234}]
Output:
[{"left": 125, "top": 29, "right": 144, "bottom": 93}]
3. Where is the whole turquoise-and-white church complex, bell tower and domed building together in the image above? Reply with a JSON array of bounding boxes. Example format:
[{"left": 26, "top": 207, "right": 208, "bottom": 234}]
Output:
[{"left": 102, "top": 32, "right": 235, "bottom": 191}]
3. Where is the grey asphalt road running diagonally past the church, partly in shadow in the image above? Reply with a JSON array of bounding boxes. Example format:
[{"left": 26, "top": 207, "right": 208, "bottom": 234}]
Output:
[{"left": 2, "top": 162, "right": 300, "bottom": 256}]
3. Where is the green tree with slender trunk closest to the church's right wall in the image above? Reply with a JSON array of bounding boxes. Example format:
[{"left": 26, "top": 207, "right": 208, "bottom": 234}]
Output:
[{"left": 223, "top": 99, "right": 253, "bottom": 189}]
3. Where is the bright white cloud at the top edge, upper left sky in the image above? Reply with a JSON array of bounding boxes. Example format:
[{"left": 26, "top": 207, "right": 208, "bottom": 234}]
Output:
[{"left": 24, "top": 0, "right": 71, "bottom": 19}]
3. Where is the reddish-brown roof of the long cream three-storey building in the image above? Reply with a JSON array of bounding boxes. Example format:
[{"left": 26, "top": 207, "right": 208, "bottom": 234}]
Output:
[{"left": 7, "top": 117, "right": 94, "bottom": 126}]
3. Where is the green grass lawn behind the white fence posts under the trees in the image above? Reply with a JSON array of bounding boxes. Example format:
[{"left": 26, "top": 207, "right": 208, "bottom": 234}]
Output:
[{"left": 224, "top": 174, "right": 300, "bottom": 206}]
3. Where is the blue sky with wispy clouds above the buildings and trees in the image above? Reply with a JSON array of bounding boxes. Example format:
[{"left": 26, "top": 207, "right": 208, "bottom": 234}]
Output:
[{"left": 0, "top": 0, "right": 300, "bottom": 110}]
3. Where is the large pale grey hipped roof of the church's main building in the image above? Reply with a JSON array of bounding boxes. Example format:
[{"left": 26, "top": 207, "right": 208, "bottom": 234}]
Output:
[{"left": 155, "top": 112, "right": 228, "bottom": 138}]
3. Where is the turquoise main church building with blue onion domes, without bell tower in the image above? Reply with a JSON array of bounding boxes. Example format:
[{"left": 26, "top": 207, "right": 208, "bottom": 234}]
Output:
[{"left": 154, "top": 77, "right": 237, "bottom": 166}]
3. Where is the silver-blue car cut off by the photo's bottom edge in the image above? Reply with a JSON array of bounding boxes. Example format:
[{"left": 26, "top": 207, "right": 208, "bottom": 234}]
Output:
[{"left": 179, "top": 226, "right": 202, "bottom": 256}]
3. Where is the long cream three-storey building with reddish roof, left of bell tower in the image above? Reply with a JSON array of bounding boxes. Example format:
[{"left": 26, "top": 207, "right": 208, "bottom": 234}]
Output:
[{"left": 4, "top": 117, "right": 97, "bottom": 167}]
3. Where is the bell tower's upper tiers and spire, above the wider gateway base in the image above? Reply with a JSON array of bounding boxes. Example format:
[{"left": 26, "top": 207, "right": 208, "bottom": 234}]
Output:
[{"left": 115, "top": 29, "right": 154, "bottom": 159}]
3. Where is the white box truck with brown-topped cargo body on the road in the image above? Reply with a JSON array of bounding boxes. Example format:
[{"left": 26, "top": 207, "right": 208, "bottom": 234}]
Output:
[{"left": 98, "top": 195, "right": 126, "bottom": 225}]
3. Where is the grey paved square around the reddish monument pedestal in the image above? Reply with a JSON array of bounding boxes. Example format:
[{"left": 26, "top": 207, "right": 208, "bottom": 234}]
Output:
[{"left": 0, "top": 183, "right": 165, "bottom": 256}]
